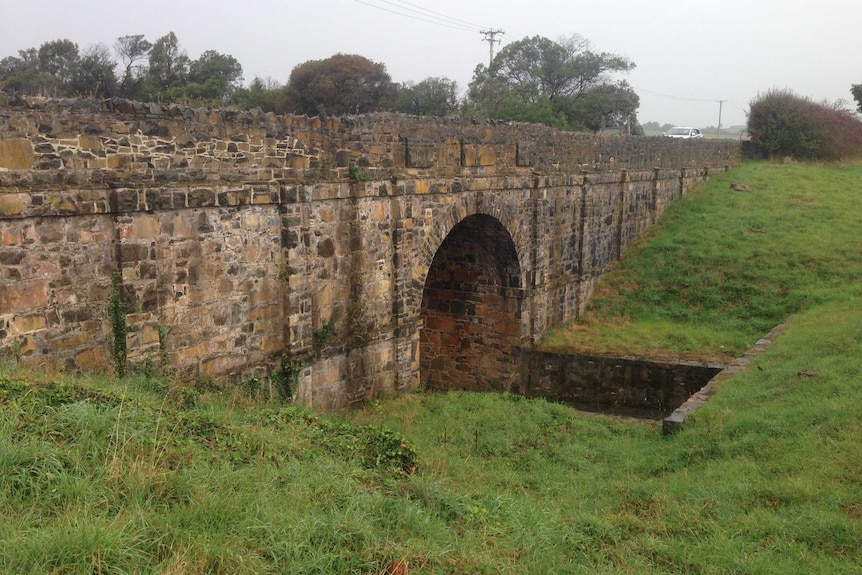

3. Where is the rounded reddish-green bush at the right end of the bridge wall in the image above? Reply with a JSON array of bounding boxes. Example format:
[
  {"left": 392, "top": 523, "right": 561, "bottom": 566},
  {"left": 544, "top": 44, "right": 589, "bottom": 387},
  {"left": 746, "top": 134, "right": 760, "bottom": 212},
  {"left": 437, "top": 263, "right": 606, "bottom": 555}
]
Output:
[{"left": 748, "top": 90, "right": 862, "bottom": 160}]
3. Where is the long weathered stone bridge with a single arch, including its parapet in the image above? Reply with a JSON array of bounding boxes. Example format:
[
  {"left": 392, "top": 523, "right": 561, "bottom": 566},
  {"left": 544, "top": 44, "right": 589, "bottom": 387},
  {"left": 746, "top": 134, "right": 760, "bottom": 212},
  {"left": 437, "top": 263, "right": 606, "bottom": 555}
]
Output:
[{"left": 0, "top": 94, "right": 740, "bottom": 408}]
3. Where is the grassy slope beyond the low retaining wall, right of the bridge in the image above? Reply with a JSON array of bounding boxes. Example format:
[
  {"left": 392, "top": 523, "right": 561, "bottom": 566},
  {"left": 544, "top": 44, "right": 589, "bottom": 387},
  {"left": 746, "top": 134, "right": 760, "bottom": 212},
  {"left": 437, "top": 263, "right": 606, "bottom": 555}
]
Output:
[{"left": 540, "top": 163, "right": 862, "bottom": 360}]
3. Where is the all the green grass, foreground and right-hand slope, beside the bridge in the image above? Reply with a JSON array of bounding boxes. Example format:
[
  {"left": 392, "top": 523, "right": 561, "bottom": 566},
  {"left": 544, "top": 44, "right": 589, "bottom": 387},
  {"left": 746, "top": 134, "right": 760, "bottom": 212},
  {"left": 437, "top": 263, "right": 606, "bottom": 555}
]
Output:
[{"left": 0, "top": 164, "right": 862, "bottom": 575}]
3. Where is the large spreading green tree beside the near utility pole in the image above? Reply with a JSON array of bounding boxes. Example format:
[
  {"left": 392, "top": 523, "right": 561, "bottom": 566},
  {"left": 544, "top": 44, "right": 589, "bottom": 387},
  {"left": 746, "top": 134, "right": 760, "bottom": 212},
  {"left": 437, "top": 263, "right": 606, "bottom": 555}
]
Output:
[{"left": 465, "top": 35, "right": 639, "bottom": 130}]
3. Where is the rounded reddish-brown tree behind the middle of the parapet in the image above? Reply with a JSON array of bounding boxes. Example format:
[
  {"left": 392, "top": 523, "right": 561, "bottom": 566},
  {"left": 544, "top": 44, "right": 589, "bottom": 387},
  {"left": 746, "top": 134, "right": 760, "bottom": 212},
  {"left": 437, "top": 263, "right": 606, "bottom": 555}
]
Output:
[{"left": 281, "top": 54, "right": 397, "bottom": 116}]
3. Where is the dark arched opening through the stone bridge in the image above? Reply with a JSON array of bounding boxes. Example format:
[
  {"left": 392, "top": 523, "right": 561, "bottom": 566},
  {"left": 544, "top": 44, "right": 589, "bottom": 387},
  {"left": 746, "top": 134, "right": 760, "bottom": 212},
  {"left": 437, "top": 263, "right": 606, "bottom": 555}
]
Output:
[{"left": 419, "top": 214, "right": 525, "bottom": 391}]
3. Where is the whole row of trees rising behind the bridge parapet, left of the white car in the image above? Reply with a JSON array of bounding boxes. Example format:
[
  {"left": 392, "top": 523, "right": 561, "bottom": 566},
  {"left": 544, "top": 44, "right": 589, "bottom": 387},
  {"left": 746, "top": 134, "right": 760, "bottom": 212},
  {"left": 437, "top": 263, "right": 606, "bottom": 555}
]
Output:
[{"left": 0, "top": 32, "right": 640, "bottom": 133}]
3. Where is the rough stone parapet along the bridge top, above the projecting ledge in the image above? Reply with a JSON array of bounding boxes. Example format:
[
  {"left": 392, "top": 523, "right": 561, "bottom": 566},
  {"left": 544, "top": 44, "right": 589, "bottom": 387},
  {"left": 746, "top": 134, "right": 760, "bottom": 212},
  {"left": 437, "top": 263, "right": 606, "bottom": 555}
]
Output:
[{"left": 0, "top": 94, "right": 740, "bottom": 191}]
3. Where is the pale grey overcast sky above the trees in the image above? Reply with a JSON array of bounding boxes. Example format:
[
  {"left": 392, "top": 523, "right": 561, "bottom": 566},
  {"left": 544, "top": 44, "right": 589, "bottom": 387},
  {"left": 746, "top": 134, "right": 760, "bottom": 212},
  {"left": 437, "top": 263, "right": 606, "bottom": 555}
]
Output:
[{"left": 0, "top": 0, "right": 862, "bottom": 127}]
